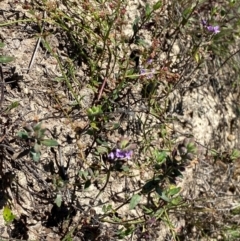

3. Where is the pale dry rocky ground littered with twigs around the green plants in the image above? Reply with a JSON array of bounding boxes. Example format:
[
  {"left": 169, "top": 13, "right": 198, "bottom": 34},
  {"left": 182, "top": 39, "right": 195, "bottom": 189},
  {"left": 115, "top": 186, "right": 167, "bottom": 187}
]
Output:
[{"left": 0, "top": 0, "right": 240, "bottom": 241}]
